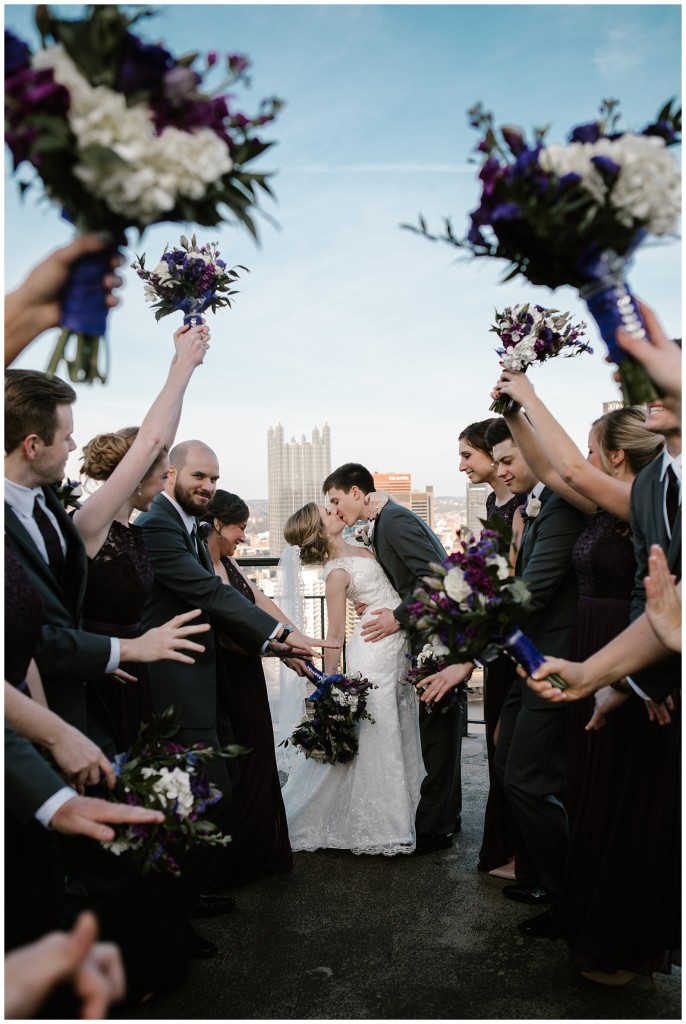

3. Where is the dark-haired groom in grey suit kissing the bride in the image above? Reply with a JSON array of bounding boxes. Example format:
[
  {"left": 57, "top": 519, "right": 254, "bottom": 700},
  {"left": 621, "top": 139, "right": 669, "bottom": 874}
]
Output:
[{"left": 323, "top": 462, "right": 466, "bottom": 854}]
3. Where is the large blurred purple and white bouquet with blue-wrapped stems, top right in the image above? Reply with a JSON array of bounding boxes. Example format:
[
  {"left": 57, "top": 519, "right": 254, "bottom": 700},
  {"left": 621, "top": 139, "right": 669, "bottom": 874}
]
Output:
[{"left": 415, "top": 100, "right": 681, "bottom": 404}]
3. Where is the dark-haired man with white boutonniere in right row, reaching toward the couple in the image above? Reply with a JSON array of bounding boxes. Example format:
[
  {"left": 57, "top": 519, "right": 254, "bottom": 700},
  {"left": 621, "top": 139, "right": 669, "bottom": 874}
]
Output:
[{"left": 423, "top": 419, "right": 586, "bottom": 935}]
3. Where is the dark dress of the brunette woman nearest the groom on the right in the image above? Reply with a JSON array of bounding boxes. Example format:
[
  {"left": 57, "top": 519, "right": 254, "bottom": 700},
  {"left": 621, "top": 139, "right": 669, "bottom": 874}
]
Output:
[{"left": 477, "top": 490, "right": 535, "bottom": 882}]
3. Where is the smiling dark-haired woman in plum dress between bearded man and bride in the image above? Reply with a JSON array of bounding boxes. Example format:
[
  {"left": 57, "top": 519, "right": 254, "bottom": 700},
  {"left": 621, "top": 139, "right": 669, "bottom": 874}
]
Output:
[{"left": 204, "top": 490, "right": 294, "bottom": 885}]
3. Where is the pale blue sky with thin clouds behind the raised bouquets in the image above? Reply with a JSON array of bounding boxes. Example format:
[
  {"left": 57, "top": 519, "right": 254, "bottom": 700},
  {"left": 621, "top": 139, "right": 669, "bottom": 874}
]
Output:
[{"left": 5, "top": 4, "right": 681, "bottom": 498}]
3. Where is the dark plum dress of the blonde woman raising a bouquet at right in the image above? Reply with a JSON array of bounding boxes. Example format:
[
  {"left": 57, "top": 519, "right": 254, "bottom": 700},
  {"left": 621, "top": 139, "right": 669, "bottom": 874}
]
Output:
[{"left": 554, "top": 511, "right": 681, "bottom": 974}]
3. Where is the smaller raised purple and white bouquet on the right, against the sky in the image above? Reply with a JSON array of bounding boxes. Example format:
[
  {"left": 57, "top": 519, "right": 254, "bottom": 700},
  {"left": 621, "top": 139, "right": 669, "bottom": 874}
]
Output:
[{"left": 490, "top": 303, "right": 593, "bottom": 416}]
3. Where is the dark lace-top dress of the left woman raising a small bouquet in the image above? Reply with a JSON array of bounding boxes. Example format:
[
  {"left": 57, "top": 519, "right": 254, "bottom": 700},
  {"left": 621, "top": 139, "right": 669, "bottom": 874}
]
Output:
[{"left": 83, "top": 521, "right": 155, "bottom": 751}]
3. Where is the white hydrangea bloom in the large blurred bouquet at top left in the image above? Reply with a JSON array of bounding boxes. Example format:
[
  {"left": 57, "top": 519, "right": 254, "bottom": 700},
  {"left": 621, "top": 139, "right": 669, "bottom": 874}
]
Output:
[{"left": 33, "top": 45, "right": 233, "bottom": 224}]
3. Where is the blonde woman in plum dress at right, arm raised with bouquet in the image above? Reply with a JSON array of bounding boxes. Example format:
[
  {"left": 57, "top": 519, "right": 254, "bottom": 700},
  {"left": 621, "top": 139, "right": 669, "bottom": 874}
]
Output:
[{"left": 498, "top": 372, "right": 681, "bottom": 985}]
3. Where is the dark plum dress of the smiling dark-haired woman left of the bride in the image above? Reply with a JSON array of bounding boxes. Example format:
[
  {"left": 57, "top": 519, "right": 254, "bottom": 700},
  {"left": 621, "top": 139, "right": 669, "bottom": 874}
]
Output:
[{"left": 217, "top": 558, "right": 293, "bottom": 885}]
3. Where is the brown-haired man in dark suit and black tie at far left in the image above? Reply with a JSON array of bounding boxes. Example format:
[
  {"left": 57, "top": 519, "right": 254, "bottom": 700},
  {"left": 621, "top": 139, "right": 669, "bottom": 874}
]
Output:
[{"left": 5, "top": 370, "right": 121, "bottom": 756}]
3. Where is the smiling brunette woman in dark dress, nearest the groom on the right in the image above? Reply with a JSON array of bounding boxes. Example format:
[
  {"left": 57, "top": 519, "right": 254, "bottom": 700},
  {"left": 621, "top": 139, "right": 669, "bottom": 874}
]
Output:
[{"left": 459, "top": 417, "right": 527, "bottom": 881}]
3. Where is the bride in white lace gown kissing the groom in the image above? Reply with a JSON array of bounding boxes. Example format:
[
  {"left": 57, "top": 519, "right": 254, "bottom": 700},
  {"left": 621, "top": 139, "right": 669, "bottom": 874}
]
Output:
[{"left": 284, "top": 502, "right": 425, "bottom": 856}]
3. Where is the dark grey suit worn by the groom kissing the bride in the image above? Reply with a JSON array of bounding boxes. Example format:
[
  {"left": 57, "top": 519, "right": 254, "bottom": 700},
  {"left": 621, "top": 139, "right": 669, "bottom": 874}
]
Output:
[{"left": 373, "top": 501, "right": 466, "bottom": 836}]
